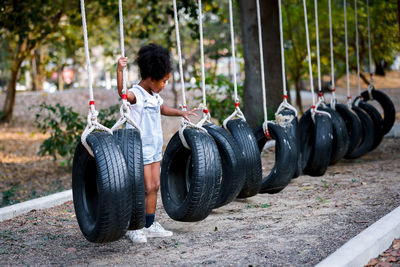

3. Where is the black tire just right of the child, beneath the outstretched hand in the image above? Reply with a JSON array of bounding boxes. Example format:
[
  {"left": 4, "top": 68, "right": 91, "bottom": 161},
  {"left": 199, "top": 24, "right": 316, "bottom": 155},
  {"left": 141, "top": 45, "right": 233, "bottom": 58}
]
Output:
[{"left": 161, "top": 128, "right": 221, "bottom": 222}]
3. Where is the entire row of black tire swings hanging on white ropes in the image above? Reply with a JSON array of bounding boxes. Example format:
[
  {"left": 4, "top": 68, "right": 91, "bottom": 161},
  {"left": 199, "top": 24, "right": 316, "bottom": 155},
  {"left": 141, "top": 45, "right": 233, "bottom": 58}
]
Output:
[{"left": 72, "top": 0, "right": 395, "bottom": 243}]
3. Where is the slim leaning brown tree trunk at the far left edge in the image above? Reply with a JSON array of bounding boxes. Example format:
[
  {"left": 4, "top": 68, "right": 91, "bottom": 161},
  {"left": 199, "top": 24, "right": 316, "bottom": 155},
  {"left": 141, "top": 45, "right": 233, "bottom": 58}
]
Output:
[{"left": 0, "top": 57, "right": 24, "bottom": 122}]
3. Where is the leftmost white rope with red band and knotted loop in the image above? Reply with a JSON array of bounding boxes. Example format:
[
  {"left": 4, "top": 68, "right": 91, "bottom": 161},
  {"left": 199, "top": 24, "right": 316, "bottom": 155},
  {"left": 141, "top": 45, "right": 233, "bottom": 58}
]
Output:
[{"left": 80, "top": 0, "right": 112, "bottom": 157}]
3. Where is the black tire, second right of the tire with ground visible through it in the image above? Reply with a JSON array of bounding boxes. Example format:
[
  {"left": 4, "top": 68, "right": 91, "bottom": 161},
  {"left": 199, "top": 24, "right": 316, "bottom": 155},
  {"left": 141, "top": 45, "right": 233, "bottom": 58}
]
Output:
[{"left": 318, "top": 106, "right": 350, "bottom": 165}]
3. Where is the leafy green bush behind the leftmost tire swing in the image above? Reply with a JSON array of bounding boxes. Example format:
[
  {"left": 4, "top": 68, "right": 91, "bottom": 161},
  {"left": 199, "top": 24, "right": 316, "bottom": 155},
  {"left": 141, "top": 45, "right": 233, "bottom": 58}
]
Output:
[{"left": 35, "top": 103, "right": 119, "bottom": 166}]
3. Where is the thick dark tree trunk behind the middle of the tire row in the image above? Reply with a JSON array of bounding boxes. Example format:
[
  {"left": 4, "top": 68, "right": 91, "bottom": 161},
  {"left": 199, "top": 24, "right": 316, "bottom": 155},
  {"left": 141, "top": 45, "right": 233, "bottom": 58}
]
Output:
[{"left": 239, "top": 0, "right": 282, "bottom": 128}]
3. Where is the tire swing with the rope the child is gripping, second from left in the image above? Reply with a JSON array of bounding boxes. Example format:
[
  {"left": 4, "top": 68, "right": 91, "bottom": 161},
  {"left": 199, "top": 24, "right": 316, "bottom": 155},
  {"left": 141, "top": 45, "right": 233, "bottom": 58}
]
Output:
[{"left": 111, "top": 0, "right": 146, "bottom": 230}]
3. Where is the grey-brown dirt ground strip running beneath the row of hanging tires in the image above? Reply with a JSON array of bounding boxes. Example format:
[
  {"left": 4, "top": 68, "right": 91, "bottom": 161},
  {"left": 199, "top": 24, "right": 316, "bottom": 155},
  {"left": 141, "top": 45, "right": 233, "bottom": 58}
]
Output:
[{"left": 0, "top": 139, "right": 400, "bottom": 266}]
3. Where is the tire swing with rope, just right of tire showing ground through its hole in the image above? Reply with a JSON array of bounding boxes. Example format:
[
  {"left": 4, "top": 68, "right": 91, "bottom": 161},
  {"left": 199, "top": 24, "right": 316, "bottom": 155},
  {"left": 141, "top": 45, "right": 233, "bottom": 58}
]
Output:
[{"left": 299, "top": 0, "right": 333, "bottom": 176}]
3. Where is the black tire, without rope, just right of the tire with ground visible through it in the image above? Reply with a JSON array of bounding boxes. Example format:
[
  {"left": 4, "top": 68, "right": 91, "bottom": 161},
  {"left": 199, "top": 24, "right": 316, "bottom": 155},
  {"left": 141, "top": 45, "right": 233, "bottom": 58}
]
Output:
[{"left": 299, "top": 110, "right": 333, "bottom": 176}]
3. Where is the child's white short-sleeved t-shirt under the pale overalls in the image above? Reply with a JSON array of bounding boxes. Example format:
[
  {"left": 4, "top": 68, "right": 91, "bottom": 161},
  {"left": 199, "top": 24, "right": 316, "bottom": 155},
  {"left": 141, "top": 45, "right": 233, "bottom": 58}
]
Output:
[{"left": 126, "top": 84, "right": 164, "bottom": 128}]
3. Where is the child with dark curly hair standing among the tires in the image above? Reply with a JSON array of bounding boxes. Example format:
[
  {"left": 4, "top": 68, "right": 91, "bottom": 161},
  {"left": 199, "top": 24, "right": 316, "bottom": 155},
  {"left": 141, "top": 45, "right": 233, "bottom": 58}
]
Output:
[{"left": 117, "top": 44, "right": 197, "bottom": 243}]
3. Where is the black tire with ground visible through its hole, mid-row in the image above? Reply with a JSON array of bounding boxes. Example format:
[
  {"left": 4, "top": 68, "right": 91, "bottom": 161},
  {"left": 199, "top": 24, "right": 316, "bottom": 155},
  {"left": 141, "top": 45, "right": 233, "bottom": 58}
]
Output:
[{"left": 254, "top": 123, "right": 298, "bottom": 194}]
